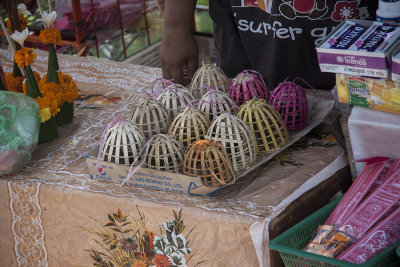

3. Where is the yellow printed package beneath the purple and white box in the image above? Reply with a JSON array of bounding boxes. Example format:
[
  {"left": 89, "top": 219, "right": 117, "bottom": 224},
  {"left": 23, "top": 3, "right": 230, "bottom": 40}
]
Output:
[{"left": 336, "top": 74, "right": 400, "bottom": 114}]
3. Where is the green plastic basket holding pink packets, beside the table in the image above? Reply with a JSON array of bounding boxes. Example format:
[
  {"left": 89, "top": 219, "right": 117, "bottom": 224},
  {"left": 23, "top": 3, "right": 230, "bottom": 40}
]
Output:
[{"left": 268, "top": 198, "right": 400, "bottom": 267}]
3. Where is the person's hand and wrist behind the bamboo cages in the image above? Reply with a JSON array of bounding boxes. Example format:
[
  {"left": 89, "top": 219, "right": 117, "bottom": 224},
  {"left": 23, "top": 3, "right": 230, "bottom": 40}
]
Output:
[{"left": 160, "top": 27, "right": 198, "bottom": 85}]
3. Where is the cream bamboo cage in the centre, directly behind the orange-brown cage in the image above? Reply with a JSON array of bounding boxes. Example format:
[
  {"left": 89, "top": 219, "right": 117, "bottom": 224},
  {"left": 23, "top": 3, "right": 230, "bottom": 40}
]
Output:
[{"left": 168, "top": 107, "right": 211, "bottom": 147}]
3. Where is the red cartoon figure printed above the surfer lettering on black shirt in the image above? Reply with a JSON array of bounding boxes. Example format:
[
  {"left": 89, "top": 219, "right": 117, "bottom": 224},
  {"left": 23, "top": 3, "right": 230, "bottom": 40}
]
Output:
[{"left": 279, "top": 0, "right": 328, "bottom": 20}]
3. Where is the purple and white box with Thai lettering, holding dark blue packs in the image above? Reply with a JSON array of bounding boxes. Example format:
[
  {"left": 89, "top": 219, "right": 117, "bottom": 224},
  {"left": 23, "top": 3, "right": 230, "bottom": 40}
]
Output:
[{"left": 316, "top": 20, "right": 400, "bottom": 78}]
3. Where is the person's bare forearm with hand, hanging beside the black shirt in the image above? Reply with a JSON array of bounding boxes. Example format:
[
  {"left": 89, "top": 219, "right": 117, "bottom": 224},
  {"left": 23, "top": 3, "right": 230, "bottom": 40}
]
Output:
[{"left": 160, "top": 0, "right": 198, "bottom": 85}]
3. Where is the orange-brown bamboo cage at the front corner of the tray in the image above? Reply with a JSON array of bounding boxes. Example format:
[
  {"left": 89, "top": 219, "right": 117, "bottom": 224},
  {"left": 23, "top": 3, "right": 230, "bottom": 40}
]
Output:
[{"left": 183, "top": 140, "right": 235, "bottom": 186}]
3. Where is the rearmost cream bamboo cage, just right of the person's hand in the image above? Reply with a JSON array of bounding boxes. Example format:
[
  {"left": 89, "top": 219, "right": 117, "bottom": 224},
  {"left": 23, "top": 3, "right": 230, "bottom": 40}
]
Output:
[{"left": 190, "top": 60, "right": 229, "bottom": 99}]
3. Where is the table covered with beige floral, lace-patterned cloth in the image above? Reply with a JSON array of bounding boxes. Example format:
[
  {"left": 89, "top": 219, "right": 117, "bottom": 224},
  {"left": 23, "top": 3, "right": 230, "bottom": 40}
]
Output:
[{"left": 0, "top": 50, "right": 349, "bottom": 266}]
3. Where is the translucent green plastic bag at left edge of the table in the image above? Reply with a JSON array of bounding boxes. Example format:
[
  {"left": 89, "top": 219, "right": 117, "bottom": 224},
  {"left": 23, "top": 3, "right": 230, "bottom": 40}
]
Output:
[{"left": 0, "top": 91, "right": 40, "bottom": 174}]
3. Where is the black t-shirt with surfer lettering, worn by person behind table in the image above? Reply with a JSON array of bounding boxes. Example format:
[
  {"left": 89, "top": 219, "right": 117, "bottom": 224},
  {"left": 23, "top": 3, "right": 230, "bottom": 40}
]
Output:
[{"left": 210, "top": 0, "right": 378, "bottom": 89}]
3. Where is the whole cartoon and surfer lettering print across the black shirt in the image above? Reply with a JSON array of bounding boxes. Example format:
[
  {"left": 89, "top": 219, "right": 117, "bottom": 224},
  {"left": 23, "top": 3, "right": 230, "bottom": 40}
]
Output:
[{"left": 236, "top": 0, "right": 371, "bottom": 45}]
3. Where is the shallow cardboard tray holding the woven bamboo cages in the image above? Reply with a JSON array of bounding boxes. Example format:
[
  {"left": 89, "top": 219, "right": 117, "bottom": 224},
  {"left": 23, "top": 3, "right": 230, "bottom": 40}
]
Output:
[{"left": 86, "top": 98, "right": 335, "bottom": 196}]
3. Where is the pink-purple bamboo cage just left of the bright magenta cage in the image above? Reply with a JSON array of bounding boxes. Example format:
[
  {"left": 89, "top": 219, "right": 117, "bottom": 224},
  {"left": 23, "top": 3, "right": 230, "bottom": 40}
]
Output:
[{"left": 229, "top": 70, "right": 269, "bottom": 106}]
